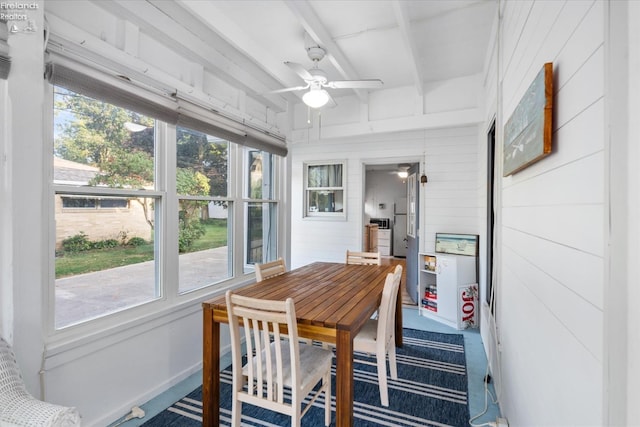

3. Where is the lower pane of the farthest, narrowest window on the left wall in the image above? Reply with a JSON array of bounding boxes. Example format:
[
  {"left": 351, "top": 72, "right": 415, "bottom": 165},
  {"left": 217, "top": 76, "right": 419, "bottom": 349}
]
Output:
[{"left": 245, "top": 202, "right": 278, "bottom": 272}]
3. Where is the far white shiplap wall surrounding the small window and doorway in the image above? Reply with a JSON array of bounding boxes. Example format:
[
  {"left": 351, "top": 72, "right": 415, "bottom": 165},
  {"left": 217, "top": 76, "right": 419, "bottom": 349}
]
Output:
[{"left": 290, "top": 126, "right": 478, "bottom": 268}]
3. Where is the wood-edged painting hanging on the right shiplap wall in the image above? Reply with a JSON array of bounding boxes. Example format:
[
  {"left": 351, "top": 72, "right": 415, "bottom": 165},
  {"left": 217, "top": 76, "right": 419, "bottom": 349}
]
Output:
[{"left": 503, "top": 62, "right": 553, "bottom": 176}]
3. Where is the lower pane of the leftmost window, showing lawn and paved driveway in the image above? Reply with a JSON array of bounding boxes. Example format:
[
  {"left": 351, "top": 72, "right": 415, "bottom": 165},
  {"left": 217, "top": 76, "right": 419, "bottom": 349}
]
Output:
[{"left": 55, "top": 195, "right": 160, "bottom": 328}]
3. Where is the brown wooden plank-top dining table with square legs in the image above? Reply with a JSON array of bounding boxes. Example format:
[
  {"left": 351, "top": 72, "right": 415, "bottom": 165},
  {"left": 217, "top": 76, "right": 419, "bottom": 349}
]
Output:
[{"left": 202, "top": 262, "right": 402, "bottom": 427}]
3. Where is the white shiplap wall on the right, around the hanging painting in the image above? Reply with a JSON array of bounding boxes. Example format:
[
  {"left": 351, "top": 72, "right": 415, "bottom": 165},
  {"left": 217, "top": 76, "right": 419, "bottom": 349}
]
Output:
[{"left": 497, "top": 1, "right": 607, "bottom": 425}]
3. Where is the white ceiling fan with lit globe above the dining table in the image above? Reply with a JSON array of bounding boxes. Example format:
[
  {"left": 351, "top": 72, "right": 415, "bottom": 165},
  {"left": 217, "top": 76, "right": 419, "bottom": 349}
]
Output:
[{"left": 269, "top": 46, "right": 383, "bottom": 108}]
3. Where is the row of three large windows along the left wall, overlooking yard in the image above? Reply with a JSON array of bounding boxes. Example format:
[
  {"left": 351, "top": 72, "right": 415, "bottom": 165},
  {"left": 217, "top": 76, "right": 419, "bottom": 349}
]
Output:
[{"left": 51, "top": 86, "right": 281, "bottom": 329}]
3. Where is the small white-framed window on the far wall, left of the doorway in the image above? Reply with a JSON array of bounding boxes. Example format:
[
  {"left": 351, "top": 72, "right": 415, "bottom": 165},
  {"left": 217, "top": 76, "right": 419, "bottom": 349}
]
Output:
[{"left": 304, "top": 162, "right": 346, "bottom": 217}]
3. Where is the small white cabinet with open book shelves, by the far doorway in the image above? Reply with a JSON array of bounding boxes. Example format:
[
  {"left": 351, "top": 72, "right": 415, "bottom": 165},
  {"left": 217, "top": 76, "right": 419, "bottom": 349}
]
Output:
[{"left": 418, "top": 253, "right": 477, "bottom": 328}]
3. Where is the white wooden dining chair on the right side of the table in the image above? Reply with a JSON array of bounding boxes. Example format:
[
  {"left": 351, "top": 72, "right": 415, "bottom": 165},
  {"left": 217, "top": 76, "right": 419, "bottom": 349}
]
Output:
[{"left": 353, "top": 265, "right": 402, "bottom": 406}]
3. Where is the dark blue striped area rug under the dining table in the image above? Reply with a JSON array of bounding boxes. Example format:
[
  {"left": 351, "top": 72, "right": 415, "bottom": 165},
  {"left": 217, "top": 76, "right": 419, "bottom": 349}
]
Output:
[{"left": 143, "top": 328, "right": 469, "bottom": 427}]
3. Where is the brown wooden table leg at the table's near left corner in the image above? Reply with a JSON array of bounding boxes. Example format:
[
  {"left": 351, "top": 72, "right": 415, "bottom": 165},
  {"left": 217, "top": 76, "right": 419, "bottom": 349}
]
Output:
[{"left": 202, "top": 309, "right": 220, "bottom": 427}]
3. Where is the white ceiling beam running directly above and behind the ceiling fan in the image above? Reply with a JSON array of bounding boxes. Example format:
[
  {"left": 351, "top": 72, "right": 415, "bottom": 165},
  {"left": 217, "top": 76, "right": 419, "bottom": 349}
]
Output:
[{"left": 285, "top": 0, "right": 369, "bottom": 103}]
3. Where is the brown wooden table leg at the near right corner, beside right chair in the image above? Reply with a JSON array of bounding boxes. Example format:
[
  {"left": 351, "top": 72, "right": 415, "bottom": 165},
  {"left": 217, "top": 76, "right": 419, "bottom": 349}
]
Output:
[{"left": 335, "top": 330, "right": 354, "bottom": 427}]
